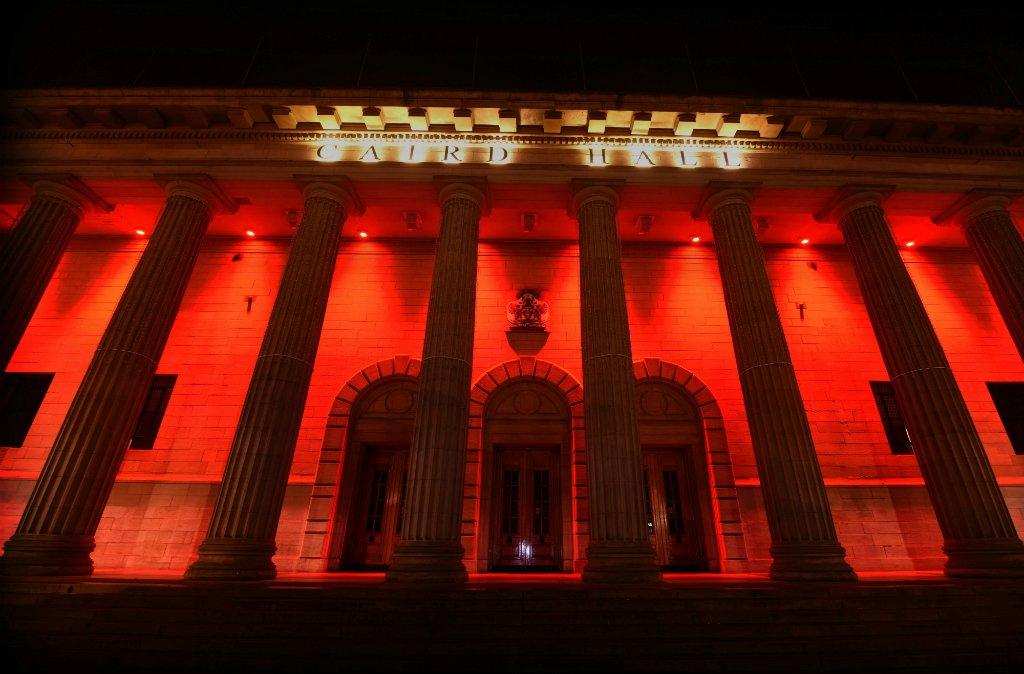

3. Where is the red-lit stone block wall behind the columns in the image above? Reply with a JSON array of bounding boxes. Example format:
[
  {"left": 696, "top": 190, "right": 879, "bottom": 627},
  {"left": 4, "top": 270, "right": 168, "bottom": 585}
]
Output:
[{"left": 0, "top": 232, "right": 1024, "bottom": 571}]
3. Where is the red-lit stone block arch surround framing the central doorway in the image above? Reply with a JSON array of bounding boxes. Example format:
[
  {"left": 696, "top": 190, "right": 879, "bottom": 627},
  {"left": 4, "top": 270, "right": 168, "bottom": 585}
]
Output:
[{"left": 462, "top": 356, "right": 589, "bottom": 573}]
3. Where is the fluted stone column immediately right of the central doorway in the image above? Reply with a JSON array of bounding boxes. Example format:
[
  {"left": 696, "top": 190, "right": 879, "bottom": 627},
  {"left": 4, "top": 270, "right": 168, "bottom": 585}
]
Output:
[{"left": 570, "top": 183, "right": 662, "bottom": 583}]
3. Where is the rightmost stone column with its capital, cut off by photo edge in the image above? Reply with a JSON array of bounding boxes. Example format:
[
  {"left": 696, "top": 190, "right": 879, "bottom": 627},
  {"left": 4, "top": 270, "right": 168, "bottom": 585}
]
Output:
[{"left": 933, "top": 189, "right": 1024, "bottom": 359}]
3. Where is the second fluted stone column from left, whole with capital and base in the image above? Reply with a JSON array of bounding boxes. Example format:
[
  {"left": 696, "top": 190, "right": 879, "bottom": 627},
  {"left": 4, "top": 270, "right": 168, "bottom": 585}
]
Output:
[{"left": 0, "top": 176, "right": 236, "bottom": 576}]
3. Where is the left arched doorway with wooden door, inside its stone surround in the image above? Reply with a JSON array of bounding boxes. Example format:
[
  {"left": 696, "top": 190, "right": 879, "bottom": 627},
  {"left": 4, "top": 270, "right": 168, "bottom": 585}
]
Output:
[{"left": 321, "top": 376, "right": 418, "bottom": 571}]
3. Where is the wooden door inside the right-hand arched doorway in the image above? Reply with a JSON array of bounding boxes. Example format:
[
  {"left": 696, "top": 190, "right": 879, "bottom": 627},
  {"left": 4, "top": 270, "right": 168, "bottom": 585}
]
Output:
[{"left": 643, "top": 448, "right": 707, "bottom": 571}]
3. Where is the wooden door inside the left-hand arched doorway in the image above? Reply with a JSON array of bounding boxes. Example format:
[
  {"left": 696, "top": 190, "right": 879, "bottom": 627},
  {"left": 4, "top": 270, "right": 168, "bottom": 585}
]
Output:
[{"left": 346, "top": 447, "right": 409, "bottom": 568}]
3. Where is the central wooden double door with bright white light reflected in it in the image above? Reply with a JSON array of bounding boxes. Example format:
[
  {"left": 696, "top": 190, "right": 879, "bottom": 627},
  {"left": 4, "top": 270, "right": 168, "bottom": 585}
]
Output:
[{"left": 492, "top": 448, "right": 561, "bottom": 571}]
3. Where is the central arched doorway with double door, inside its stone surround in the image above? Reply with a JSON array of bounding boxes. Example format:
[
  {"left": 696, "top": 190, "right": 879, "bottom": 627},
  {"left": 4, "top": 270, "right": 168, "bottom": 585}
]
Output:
[{"left": 478, "top": 377, "right": 572, "bottom": 572}]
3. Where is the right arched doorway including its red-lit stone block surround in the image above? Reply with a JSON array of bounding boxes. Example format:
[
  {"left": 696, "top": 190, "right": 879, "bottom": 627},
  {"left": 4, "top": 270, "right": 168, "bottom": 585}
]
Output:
[{"left": 634, "top": 359, "right": 746, "bottom": 572}]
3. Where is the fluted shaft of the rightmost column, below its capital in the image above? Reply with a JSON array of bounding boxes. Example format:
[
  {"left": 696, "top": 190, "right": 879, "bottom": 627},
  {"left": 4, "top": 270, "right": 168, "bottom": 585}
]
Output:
[{"left": 964, "top": 200, "right": 1024, "bottom": 359}]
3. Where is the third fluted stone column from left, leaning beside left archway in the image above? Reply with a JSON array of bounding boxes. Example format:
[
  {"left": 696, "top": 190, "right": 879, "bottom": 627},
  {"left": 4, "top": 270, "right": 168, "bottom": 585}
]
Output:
[{"left": 185, "top": 181, "right": 362, "bottom": 581}]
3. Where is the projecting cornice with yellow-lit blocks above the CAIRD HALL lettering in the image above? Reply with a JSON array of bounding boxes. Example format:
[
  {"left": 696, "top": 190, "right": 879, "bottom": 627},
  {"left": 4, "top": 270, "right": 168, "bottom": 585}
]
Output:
[{"left": 0, "top": 89, "right": 1024, "bottom": 157}]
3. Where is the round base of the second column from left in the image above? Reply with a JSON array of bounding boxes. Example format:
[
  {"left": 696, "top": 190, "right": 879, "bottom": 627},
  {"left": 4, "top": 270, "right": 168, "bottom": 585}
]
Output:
[{"left": 0, "top": 534, "right": 96, "bottom": 576}]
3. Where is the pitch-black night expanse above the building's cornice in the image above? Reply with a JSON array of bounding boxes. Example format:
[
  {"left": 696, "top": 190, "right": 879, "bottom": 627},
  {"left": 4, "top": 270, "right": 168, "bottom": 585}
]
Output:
[{"left": 3, "top": 0, "right": 1024, "bottom": 106}]
